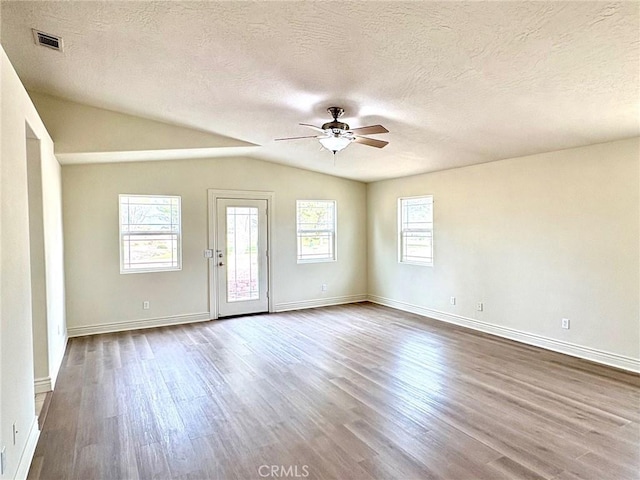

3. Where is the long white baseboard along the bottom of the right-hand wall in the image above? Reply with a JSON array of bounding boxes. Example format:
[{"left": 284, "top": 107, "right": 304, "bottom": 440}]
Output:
[{"left": 368, "top": 295, "right": 640, "bottom": 373}]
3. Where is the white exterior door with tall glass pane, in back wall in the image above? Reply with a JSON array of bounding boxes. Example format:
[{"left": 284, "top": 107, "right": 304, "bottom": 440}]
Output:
[{"left": 214, "top": 198, "right": 269, "bottom": 317}]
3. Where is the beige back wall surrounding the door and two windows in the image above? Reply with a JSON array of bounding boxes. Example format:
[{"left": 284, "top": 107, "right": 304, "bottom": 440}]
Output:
[{"left": 62, "top": 158, "right": 367, "bottom": 334}]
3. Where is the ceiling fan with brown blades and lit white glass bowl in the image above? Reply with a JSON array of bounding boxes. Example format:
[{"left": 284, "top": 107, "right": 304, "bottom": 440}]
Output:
[{"left": 276, "top": 107, "right": 389, "bottom": 155}]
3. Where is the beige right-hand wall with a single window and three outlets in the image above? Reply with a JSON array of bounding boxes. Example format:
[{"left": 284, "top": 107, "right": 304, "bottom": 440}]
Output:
[{"left": 368, "top": 138, "right": 640, "bottom": 368}]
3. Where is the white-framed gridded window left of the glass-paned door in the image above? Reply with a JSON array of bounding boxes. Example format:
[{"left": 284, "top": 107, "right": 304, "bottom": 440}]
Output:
[{"left": 120, "top": 195, "right": 182, "bottom": 273}]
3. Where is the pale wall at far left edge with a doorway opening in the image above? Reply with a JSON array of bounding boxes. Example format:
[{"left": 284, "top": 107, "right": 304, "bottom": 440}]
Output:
[{"left": 0, "top": 49, "right": 65, "bottom": 478}]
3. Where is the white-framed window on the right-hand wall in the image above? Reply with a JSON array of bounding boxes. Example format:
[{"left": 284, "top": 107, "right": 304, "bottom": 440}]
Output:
[{"left": 398, "top": 195, "right": 433, "bottom": 265}]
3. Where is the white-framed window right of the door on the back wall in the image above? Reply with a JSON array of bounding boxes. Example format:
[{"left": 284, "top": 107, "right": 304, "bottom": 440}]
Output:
[{"left": 296, "top": 200, "right": 336, "bottom": 263}]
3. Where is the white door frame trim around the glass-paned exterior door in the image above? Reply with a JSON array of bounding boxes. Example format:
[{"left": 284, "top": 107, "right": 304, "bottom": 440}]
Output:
[{"left": 207, "top": 188, "right": 275, "bottom": 320}]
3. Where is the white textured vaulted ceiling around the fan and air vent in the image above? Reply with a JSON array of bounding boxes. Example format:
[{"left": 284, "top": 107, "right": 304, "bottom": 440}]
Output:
[{"left": 1, "top": 1, "right": 640, "bottom": 181}]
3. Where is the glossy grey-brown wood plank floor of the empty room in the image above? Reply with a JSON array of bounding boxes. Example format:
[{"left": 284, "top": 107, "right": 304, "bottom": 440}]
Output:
[{"left": 29, "top": 303, "right": 640, "bottom": 480}]
